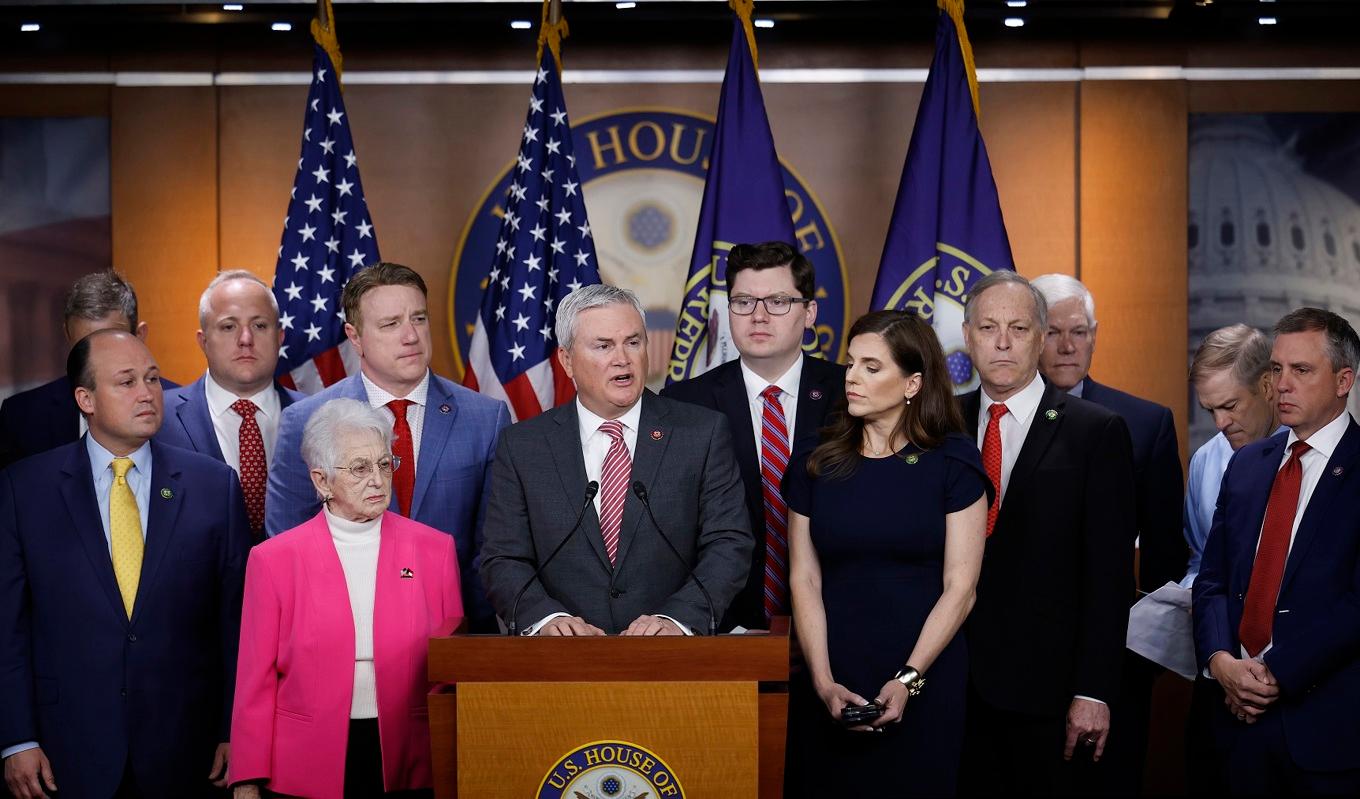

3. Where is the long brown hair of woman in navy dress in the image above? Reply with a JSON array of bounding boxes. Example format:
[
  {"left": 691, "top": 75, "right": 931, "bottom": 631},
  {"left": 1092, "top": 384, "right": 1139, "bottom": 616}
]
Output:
[{"left": 808, "top": 311, "right": 963, "bottom": 480}]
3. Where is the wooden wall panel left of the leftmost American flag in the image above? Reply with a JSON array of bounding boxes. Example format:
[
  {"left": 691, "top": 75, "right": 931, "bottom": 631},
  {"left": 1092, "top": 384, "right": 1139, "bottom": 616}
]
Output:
[{"left": 110, "top": 87, "right": 218, "bottom": 383}]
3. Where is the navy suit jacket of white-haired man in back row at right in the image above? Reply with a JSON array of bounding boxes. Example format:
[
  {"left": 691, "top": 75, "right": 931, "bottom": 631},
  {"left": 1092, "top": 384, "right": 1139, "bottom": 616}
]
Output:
[{"left": 1081, "top": 376, "right": 1190, "bottom": 592}]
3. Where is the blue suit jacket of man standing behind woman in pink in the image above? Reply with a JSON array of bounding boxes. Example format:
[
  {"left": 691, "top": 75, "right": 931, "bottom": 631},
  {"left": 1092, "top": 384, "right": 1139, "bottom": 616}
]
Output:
[{"left": 264, "top": 372, "right": 510, "bottom": 626}]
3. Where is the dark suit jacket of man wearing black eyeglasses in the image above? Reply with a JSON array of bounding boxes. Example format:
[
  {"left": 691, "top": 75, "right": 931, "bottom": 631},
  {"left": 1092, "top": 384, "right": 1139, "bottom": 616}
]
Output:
[{"left": 661, "top": 355, "right": 846, "bottom": 631}]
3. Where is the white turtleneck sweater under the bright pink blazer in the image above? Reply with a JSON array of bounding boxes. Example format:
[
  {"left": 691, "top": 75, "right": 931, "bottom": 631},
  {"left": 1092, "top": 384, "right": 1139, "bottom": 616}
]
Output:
[{"left": 330, "top": 505, "right": 382, "bottom": 719}]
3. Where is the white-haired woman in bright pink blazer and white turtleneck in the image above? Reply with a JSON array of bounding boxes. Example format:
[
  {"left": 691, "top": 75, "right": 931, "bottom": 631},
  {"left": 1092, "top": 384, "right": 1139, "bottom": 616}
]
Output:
[{"left": 230, "top": 400, "right": 462, "bottom": 799}]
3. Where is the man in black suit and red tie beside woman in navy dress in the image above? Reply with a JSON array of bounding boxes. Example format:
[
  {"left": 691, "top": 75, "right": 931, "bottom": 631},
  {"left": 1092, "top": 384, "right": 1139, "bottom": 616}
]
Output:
[{"left": 960, "top": 272, "right": 1134, "bottom": 795}]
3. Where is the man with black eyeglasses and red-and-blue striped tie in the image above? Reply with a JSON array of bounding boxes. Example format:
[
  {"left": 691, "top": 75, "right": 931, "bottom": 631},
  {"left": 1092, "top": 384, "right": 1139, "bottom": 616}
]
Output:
[{"left": 661, "top": 242, "right": 845, "bottom": 631}]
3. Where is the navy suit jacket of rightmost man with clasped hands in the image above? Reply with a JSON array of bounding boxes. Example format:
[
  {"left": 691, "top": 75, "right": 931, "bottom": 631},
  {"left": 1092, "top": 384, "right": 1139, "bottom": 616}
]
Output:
[{"left": 1193, "top": 420, "right": 1360, "bottom": 770}]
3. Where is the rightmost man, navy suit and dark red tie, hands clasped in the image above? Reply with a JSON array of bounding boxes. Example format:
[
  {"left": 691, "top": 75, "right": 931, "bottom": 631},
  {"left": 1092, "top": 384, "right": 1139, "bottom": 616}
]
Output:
[{"left": 1194, "top": 308, "right": 1360, "bottom": 795}]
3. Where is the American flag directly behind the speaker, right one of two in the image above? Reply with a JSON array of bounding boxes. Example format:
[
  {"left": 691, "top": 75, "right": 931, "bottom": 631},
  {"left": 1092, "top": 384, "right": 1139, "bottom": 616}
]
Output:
[{"left": 462, "top": 48, "right": 600, "bottom": 421}]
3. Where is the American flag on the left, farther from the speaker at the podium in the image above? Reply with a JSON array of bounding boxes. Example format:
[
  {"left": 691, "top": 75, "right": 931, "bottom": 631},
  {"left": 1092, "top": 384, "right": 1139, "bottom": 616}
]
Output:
[{"left": 273, "top": 43, "right": 378, "bottom": 394}]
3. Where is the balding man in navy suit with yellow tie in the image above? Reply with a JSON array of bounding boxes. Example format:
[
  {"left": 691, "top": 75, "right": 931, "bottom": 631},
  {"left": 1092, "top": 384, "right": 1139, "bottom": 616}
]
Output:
[{"left": 0, "top": 330, "right": 250, "bottom": 799}]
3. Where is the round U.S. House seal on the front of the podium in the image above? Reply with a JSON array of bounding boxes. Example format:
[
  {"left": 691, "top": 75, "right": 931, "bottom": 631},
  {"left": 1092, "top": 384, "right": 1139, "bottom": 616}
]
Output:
[{"left": 534, "top": 741, "right": 684, "bottom": 799}]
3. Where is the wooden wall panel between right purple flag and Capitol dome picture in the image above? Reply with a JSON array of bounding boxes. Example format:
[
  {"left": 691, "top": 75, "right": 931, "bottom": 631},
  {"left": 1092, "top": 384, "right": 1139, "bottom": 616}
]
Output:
[{"left": 1080, "top": 82, "right": 1187, "bottom": 457}]
